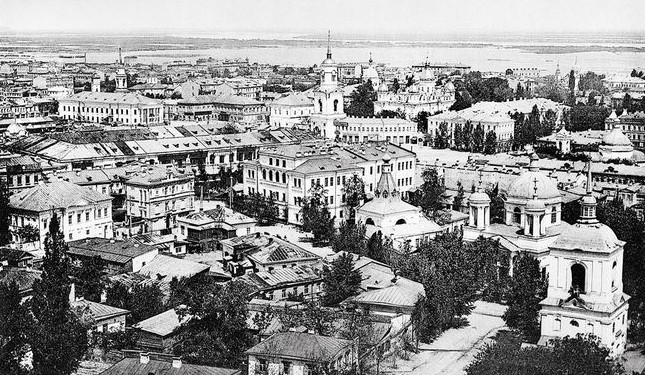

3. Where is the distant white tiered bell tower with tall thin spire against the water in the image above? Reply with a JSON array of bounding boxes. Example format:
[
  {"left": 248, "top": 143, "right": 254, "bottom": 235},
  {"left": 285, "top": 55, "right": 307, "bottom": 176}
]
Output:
[{"left": 311, "top": 32, "right": 345, "bottom": 139}]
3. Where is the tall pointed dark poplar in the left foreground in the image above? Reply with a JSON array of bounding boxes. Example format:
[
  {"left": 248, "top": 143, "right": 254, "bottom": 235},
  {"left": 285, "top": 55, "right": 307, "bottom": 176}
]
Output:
[{"left": 29, "top": 214, "right": 88, "bottom": 375}]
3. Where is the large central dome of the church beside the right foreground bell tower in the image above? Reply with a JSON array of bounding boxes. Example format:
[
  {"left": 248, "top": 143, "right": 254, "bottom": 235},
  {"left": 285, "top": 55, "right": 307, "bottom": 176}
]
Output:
[{"left": 508, "top": 154, "right": 562, "bottom": 200}]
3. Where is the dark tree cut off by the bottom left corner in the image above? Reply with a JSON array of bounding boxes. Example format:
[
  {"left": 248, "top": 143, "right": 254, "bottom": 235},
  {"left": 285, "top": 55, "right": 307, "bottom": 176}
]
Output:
[{"left": 0, "top": 282, "right": 33, "bottom": 375}]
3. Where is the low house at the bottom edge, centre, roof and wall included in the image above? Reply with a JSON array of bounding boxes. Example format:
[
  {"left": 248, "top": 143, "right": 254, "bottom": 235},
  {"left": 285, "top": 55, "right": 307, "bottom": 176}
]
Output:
[{"left": 246, "top": 332, "right": 358, "bottom": 375}]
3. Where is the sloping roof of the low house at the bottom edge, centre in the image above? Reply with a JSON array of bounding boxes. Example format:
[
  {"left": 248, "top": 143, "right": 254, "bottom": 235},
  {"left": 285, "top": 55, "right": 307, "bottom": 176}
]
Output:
[{"left": 246, "top": 332, "right": 352, "bottom": 362}]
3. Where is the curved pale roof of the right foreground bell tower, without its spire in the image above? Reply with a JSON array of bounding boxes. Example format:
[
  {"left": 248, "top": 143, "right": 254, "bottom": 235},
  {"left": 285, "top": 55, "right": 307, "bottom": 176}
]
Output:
[{"left": 551, "top": 223, "right": 625, "bottom": 253}]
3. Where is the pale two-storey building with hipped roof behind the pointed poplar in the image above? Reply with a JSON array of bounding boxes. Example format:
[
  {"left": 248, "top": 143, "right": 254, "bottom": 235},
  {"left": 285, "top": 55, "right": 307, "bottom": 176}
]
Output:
[{"left": 9, "top": 181, "right": 113, "bottom": 247}]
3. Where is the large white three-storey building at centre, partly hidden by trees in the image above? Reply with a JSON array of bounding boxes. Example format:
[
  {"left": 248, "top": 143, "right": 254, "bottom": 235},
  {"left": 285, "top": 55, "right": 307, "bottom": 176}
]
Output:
[{"left": 244, "top": 142, "right": 415, "bottom": 224}]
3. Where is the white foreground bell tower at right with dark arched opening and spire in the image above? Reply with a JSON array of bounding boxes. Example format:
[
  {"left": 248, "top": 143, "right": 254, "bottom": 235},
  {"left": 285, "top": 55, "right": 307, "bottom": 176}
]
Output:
[{"left": 540, "top": 162, "right": 629, "bottom": 356}]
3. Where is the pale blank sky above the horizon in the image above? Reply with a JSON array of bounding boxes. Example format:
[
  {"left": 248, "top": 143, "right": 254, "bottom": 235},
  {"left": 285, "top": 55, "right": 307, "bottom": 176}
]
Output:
[{"left": 0, "top": 0, "right": 645, "bottom": 35}]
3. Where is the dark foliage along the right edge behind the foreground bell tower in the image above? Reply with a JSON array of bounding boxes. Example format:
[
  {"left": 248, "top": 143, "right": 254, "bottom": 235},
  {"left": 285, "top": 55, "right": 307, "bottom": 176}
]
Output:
[{"left": 597, "top": 200, "right": 645, "bottom": 343}]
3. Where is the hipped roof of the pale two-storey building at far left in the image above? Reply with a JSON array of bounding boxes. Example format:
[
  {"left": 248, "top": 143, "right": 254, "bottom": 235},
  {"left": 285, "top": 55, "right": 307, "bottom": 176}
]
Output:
[{"left": 9, "top": 181, "right": 112, "bottom": 212}]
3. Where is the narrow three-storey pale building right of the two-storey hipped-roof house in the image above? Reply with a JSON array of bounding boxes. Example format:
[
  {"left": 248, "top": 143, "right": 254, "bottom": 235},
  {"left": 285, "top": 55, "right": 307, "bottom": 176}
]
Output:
[{"left": 124, "top": 165, "right": 194, "bottom": 234}]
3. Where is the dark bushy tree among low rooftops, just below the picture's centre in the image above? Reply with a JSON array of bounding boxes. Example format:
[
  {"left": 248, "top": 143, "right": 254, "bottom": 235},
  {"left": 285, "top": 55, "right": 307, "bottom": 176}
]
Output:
[{"left": 321, "top": 253, "right": 361, "bottom": 306}]
